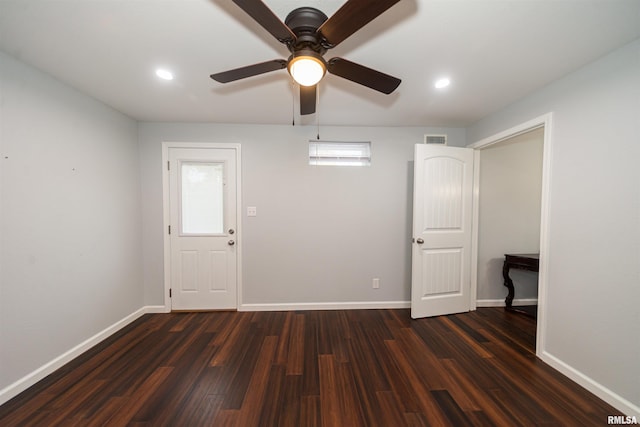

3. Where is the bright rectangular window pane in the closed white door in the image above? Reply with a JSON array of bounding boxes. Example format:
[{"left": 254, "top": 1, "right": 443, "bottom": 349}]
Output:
[{"left": 180, "top": 162, "right": 224, "bottom": 234}]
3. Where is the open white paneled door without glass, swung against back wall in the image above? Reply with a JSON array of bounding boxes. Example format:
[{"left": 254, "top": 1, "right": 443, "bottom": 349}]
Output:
[{"left": 411, "top": 144, "right": 474, "bottom": 319}]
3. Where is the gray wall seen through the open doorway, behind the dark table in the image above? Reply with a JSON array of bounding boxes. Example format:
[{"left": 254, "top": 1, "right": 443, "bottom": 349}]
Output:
[{"left": 478, "top": 129, "right": 544, "bottom": 305}]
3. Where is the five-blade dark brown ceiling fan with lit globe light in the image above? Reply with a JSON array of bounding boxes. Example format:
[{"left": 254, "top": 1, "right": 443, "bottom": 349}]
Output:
[{"left": 211, "top": 0, "right": 400, "bottom": 115}]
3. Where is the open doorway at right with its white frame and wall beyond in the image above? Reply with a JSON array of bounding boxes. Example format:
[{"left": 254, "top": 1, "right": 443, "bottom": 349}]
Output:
[{"left": 469, "top": 113, "right": 551, "bottom": 355}]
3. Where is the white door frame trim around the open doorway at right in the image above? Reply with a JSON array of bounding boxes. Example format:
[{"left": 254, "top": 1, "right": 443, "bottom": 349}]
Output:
[{"left": 467, "top": 112, "right": 553, "bottom": 358}]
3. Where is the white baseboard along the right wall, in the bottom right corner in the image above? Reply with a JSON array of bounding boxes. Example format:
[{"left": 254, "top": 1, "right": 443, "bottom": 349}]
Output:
[{"left": 540, "top": 351, "right": 640, "bottom": 418}]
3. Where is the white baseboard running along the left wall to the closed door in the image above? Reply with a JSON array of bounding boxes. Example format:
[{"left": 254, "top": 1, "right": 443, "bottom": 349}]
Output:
[{"left": 0, "top": 306, "right": 159, "bottom": 405}]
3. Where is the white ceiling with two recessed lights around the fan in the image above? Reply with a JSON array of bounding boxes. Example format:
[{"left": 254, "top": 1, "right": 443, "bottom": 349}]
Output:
[{"left": 0, "top": 0, "right": 640, "bottom": 126}]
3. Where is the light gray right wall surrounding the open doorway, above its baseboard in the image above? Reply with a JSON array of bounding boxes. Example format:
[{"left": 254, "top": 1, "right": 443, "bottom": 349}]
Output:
[{"left": 467, "top": 40, "right": 640, "bottom": 414}]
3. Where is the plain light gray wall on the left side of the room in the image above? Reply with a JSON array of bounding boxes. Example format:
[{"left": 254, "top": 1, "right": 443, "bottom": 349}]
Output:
[{"left": 0, "top": 53, "right": 143, "bottom": 390}]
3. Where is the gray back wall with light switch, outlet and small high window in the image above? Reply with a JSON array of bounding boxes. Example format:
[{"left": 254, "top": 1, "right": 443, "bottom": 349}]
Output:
[{"left": 139, "top": 123, "right": 466, "bottom": 305}]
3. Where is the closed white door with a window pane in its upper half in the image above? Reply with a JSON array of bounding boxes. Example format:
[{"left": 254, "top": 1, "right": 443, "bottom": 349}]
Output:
[{"left": 169, "top": 148, "right": 238, "bottom": 310}]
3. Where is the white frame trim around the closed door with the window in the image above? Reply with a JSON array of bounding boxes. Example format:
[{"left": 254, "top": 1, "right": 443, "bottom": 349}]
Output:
[{"left": 161, "top": 142, "right": 243, "bottom": 313}]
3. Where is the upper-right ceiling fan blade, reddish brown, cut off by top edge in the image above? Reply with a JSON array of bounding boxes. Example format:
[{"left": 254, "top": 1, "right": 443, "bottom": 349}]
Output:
[{"left": 318, "top": 0, "right": 400, "bottom": 46}]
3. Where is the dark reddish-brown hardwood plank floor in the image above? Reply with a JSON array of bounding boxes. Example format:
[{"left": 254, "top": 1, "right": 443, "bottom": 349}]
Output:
[{"left": 0, "top": 308, "right": 619, "bottom": 427}]
